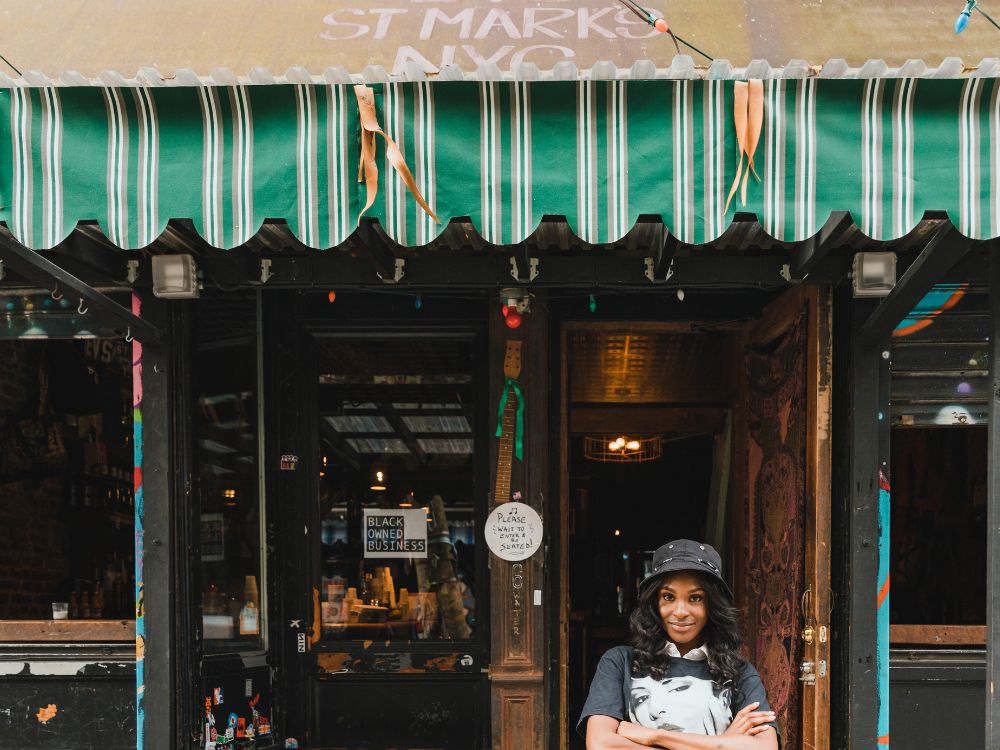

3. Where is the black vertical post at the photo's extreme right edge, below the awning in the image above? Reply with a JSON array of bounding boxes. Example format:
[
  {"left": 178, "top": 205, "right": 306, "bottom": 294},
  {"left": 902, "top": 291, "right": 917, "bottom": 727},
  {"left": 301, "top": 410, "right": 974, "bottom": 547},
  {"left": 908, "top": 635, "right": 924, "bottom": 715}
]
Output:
[{"left": 984, "top": 240, "right": 1000, "bottom": 747}]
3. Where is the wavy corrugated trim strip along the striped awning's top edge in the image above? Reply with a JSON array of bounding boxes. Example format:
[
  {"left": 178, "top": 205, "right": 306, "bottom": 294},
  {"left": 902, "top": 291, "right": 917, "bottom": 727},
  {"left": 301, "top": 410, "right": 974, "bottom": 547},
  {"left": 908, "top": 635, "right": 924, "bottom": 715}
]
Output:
[{"left": 0, "top": 55, "right": 1000, "bottom": 88}]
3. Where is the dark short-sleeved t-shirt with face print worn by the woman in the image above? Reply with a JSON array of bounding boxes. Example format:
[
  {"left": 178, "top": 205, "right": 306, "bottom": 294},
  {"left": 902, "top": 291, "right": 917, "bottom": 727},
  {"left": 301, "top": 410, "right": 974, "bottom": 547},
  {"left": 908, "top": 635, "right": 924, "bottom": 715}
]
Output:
[{"left": 576, "top": 646, "right": 777, "bottom": 734}]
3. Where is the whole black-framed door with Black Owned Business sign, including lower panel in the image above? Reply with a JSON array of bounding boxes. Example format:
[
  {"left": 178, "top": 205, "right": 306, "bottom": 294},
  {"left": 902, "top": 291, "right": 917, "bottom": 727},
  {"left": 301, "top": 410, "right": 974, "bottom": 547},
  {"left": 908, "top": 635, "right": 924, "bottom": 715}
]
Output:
[{"left": 308, "top": 331, "right": 489, "bottom": 750}]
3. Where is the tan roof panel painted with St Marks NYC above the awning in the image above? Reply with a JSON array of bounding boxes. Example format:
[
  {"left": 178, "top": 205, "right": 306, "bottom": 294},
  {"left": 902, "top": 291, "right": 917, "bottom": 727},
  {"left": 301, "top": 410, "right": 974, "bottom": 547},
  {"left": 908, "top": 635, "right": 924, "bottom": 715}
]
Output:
[{"left": 9, "top": 0, "right": 997, "bottom": 76}]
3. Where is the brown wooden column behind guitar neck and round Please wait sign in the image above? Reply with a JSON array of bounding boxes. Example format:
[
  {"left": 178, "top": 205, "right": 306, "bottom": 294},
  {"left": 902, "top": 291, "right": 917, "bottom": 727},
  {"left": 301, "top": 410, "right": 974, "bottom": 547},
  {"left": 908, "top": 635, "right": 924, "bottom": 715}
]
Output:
[{"left": 489, "top": 299, "right": 557, "bottom": 750}]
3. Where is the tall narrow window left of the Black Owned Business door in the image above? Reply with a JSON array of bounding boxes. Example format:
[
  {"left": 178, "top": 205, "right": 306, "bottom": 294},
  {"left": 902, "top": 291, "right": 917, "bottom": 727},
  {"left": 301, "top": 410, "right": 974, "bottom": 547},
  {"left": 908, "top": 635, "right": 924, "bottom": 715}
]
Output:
[{"left": 192, "top": 299, "right": 266, "bottom": 653}]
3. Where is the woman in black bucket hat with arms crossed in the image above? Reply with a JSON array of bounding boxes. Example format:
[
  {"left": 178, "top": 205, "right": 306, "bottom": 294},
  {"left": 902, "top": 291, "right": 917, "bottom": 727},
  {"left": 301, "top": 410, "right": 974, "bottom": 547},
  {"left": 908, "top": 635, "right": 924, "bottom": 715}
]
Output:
[{"left": 577, "top": 539, "right": 779, "bottom": 750}]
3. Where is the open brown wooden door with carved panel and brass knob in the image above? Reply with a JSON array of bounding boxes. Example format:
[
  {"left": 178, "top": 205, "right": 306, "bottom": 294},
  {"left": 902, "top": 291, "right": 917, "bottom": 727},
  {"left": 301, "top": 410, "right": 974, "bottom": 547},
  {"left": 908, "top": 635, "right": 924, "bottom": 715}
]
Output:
[{"left": 733, "top": 286, "right": 832, "bottom": 748}]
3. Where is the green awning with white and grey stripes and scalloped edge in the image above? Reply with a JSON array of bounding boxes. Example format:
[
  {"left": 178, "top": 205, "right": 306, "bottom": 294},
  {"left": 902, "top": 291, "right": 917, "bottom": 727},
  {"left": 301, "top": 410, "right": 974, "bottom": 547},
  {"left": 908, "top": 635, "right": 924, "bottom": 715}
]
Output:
[{"left": 0, "top": 78, "right": 1000, "bottom": 249}]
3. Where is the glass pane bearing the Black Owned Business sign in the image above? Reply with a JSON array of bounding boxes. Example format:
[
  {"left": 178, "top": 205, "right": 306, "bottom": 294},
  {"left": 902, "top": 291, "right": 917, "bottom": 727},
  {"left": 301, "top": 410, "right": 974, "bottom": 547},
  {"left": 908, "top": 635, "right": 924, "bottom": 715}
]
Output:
[{"left": 318, "top": 338, "right": 477, "bottom": 641}]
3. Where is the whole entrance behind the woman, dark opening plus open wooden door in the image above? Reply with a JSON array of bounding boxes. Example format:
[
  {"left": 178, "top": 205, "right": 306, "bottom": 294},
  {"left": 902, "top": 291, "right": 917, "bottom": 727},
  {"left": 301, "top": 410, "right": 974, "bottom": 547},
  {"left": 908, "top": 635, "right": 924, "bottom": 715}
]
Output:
[{"left": 558, "top": 285, "right": 832, "bottom": 748}]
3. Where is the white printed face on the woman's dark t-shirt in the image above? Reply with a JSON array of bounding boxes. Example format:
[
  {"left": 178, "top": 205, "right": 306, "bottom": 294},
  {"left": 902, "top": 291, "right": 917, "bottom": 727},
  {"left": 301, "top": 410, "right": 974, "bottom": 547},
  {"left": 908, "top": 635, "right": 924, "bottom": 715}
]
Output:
[{"left": 629, "top": 676, "right": 732, "bottom": 735}]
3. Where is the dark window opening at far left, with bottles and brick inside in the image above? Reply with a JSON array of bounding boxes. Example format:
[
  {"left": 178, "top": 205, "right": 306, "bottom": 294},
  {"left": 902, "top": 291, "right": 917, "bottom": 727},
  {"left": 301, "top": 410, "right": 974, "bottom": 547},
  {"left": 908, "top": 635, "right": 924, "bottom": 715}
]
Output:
[{"left": 0, "top": 334, "right": 135, "bottom": 624}]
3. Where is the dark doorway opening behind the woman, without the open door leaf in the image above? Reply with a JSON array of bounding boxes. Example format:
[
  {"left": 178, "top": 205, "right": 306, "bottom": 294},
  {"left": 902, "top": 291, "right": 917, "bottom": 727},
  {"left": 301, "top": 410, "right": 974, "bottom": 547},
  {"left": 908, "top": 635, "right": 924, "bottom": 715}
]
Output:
[{"left": 564, "top": 323, "right": 739, "bottom": 750}]
